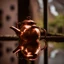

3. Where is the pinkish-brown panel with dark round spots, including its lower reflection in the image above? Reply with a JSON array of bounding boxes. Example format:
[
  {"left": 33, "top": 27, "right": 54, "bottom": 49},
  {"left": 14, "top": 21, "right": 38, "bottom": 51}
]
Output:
[{"left": 0, "top": 0, "right": 18, "bottom": 64}]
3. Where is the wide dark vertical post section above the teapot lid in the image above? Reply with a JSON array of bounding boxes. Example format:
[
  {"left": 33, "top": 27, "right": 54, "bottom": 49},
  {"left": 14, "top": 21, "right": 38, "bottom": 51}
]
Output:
[{"left": 18, "top": 0, "right": 31, "bottom": 22}]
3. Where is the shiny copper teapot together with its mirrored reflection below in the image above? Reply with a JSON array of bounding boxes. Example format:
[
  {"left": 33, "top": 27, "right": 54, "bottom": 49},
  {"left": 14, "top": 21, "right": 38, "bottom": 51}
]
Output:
[{"left": 10, "top": 19, "right": 45, "bottom": 60}]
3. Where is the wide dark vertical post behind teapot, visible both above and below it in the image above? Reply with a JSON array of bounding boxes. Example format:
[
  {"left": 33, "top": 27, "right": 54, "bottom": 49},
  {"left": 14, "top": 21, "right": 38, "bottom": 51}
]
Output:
[{"left": 18, "top": 0, "right": 30, "bottom": 64}]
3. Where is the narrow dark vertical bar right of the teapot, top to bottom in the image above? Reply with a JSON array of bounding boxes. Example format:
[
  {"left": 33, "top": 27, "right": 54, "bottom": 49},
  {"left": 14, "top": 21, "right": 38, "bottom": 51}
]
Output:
[{"left": 43, "top": 0, "right": 48, "bottom": 64}]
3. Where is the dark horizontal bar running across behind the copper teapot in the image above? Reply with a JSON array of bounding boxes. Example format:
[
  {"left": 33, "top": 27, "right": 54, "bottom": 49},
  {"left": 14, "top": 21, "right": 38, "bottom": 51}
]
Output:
[{"left": 0, "top": 36, "right": 64, "bottom": 42}]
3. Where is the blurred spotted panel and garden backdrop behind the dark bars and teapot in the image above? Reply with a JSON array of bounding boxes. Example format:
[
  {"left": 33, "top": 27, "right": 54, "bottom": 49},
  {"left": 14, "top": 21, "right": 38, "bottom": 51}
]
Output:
[{"left": 0, "top": 0, "right": 64, "bottom": 64}]
